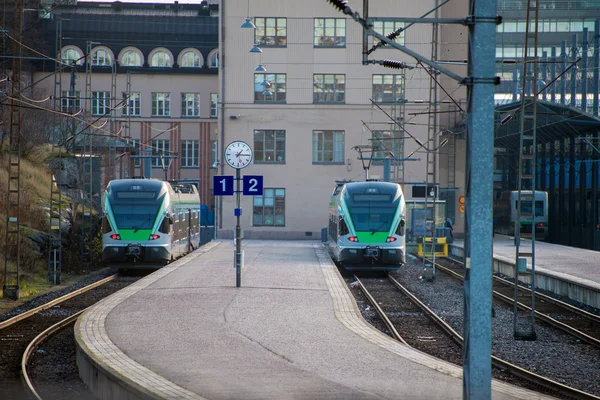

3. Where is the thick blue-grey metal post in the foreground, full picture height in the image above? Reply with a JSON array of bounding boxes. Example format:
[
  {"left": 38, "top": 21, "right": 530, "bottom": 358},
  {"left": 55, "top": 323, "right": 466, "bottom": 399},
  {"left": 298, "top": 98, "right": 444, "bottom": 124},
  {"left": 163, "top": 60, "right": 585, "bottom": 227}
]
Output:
[{"left": 463, "top": 0, "right": 497, "bottom": 399}]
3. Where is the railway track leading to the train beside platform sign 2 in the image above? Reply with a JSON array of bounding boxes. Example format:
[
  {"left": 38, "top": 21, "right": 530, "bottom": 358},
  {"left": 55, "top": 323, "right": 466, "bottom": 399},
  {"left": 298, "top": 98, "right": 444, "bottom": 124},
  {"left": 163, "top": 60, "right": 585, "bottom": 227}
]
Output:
[{"left": 354, "top": 276, "right": 600, "bottom": 399}]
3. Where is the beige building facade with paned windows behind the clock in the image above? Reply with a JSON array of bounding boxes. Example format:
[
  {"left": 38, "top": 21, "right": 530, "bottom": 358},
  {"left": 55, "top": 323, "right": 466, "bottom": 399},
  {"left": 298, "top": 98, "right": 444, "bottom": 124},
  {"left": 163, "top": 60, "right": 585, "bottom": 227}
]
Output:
[{"left": 218, "top": 0, "right": 466, "bottom": 239}]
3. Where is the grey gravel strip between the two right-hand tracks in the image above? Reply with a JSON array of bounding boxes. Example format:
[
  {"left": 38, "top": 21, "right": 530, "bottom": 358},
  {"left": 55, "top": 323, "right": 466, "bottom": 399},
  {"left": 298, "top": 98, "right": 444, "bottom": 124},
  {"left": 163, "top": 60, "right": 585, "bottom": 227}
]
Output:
[{"left": 380, "top": 256, "right": 600, "bottom": 396}]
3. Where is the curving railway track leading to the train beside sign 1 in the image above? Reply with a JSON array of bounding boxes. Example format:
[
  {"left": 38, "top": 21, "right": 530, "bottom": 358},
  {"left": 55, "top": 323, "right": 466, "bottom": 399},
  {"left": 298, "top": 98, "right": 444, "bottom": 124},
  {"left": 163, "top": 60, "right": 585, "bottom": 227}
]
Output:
[{"left": 0, "top": 275, "right": 138, "bottom": 399}]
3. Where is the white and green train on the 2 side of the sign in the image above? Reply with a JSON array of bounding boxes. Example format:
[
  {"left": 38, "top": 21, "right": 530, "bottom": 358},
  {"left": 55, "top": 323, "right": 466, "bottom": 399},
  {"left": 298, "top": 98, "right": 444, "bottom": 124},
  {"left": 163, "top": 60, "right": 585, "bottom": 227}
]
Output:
[{"left": 328, "top": 181, "right": 406, "bottom": 271}]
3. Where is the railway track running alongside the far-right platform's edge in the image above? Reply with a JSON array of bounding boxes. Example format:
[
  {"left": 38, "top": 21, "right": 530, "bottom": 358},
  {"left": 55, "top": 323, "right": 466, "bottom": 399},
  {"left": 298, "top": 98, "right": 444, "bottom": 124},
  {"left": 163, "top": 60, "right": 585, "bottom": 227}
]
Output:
[{"left": 428, "top": 260, "right": 600, "bottom": 348}]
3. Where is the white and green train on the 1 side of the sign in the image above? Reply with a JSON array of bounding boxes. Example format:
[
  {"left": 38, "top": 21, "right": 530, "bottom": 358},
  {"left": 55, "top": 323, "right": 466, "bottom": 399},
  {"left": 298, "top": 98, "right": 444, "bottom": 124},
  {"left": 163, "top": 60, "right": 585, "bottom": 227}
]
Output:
[{"left": 102, "top": 179, "right": 200, "bottom": 269}]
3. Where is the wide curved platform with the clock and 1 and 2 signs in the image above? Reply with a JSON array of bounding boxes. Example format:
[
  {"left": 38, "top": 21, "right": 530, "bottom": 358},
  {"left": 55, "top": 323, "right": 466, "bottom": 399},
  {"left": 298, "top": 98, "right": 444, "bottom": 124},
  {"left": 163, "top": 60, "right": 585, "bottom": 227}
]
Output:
[{"left": 75, "top": 240, "right": 550, "bottom": 400}]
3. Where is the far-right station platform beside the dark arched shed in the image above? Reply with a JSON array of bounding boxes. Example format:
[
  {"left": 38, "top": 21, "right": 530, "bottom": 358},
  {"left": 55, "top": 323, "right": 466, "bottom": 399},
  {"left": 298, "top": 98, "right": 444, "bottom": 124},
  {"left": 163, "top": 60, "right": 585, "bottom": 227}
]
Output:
[{"left": 449, "top": 235, "right": 600, "bottom": 309}]
